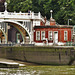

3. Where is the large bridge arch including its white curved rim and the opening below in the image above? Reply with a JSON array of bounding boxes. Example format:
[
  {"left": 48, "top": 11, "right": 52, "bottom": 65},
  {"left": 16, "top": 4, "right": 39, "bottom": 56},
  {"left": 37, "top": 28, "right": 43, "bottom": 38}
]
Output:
[{"left": 0, "top": 20, "right": 30, "bottom": 44}]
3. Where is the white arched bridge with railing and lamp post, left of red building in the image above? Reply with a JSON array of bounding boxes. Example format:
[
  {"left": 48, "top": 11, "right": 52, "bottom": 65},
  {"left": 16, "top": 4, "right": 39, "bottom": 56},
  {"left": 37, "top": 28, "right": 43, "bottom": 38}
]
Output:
[{"left": 0, "top": 2, "right": 42, "bottom": 44}]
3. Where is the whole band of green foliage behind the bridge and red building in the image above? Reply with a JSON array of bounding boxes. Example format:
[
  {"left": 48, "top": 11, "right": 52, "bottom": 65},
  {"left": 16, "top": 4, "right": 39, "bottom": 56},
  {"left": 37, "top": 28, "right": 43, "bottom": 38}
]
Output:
[{"left": 7, "top": 0, "right": 75, "bottom": 25}]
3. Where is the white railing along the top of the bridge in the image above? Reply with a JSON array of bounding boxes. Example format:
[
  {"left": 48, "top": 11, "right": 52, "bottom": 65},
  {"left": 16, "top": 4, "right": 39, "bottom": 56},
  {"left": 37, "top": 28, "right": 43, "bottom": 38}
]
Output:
[{"left": 0, "top": 12, "right": 41, "bottom": 19}]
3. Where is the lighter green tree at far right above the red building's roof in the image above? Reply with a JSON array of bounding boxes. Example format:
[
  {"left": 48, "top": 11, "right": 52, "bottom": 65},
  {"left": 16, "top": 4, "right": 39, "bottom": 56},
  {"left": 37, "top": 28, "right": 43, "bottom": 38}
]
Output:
[{"left": 55, "top": 0, "right": 75, "bottom": 24}]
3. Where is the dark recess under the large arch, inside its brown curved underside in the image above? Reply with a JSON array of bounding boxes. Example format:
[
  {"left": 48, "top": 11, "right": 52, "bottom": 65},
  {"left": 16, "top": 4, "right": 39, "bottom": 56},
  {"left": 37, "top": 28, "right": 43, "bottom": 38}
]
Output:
[{"left": 8, "top": 23, "right": 23, "bottom": 44}]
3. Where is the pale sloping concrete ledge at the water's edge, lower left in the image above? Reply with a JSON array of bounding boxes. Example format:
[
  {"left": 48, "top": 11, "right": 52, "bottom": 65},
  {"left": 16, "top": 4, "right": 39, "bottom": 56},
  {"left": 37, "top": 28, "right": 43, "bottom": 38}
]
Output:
[{"left": 0, "top": 58, "right": 37, "bottom": 68}]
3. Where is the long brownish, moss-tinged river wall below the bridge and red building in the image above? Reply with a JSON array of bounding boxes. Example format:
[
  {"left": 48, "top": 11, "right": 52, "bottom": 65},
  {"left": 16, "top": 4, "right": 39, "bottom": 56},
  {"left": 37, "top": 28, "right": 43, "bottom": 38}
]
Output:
[{"left": 0, "top": 47, "right": 75, "bottom": 65}]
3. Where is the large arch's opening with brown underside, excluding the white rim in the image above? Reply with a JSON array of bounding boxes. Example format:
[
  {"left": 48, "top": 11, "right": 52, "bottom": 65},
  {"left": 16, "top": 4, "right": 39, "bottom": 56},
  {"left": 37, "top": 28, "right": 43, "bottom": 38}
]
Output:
[{"left": 8, "top": 23, "right": 30, "bottom": 44}]
